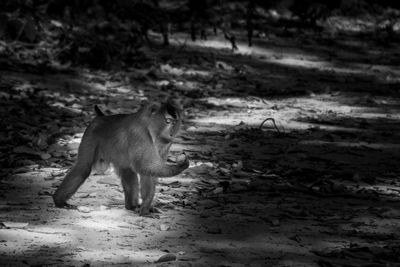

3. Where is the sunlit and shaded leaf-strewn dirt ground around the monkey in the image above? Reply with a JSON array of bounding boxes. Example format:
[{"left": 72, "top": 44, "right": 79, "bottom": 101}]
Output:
[{"left": 0, "top": 34, "right": 400, "bottom": 267}]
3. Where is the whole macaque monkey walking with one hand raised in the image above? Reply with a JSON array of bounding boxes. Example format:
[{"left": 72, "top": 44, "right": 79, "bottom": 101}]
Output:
[{"left": 53, "top": 102, "right": 189, "bottom": 216}]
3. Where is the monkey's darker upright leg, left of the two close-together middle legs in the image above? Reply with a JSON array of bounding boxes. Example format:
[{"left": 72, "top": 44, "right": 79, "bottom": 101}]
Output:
[{"left": 118, "top": 168, "right": 139, "bottom": 210}]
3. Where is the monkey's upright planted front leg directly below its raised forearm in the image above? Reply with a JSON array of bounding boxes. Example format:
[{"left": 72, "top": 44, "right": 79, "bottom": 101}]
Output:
[{"left": 140, "top": 175, "right": 158, "bottom": 216}]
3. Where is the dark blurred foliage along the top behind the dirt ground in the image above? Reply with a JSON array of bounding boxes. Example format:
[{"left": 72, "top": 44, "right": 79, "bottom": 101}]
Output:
[{"left": 0, "top": 0, "right": 400, "bottom": 68}]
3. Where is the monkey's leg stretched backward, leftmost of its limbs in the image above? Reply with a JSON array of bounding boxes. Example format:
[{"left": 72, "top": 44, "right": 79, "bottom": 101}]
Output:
[{"left": 53, "top": 162, "right": 91, "bottom": 208}]
